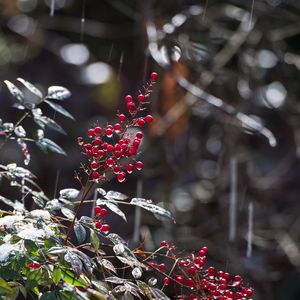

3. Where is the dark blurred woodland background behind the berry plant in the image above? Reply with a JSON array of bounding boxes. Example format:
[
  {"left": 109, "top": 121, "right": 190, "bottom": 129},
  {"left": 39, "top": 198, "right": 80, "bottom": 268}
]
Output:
[{"left": 0, "top": 0, "right": 300, "bottom": 300}]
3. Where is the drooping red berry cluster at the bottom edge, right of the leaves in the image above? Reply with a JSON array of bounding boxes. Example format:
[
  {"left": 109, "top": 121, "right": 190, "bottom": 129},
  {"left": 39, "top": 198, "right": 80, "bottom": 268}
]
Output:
[{"left": 141, "top": 241, "right": 253, "bottom": 300}]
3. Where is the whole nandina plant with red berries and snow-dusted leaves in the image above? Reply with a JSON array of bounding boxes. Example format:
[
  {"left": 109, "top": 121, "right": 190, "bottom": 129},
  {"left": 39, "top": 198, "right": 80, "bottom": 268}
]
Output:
[{"left": 0, "top": 73, "right": 253, "bottom": 300}]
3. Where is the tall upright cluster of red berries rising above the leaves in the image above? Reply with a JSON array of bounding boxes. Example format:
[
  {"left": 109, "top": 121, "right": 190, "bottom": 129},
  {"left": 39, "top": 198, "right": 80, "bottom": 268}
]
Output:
[{"left": 78, "top": 72, "right": 158, "bottom": 182}]
